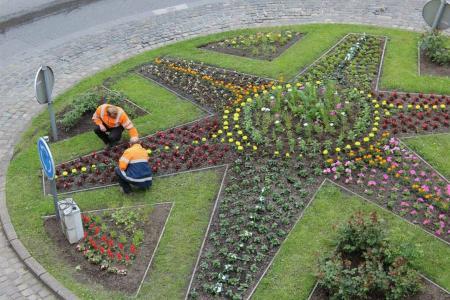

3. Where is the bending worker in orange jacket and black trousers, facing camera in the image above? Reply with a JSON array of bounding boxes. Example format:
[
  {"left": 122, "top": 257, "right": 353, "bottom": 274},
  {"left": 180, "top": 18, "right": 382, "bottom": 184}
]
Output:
[{"left": 92, "top": 104, "right": 138, "bottom": 148}]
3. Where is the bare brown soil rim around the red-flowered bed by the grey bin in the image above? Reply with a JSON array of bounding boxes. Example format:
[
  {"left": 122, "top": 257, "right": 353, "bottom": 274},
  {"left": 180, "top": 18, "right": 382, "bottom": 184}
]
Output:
[{"left": 44, "top": 203, "right": 172, "bottom": 294}]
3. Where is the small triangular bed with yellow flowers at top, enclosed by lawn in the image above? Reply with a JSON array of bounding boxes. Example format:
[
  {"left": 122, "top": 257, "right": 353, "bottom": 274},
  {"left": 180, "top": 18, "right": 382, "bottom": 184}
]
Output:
[{"left": 200, "top": 30, "right": 303, "bottom": 61}]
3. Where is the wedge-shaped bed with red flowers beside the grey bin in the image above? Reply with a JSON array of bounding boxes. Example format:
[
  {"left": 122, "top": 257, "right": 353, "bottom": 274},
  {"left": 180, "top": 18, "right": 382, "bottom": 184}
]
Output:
[{"left": 45, "top": 204, "right": 171, "bottom": 293}]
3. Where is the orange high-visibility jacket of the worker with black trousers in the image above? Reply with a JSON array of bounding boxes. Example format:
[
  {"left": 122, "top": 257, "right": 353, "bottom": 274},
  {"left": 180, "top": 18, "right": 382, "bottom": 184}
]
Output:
[{"left": 92, "top": 104, "right": 138, "bottom": 137}]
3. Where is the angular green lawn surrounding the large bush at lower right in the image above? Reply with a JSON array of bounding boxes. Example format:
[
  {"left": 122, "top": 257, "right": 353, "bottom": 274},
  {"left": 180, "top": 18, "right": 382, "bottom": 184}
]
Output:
[{"left": 253, "top": 183, "right": 450, "bottom": 300}]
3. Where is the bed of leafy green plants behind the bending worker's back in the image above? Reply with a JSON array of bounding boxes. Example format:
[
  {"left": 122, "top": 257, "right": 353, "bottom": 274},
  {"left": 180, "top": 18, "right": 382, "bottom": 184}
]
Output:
[{"left": 53, "top": 87, "right": 148, "bottom": 139}]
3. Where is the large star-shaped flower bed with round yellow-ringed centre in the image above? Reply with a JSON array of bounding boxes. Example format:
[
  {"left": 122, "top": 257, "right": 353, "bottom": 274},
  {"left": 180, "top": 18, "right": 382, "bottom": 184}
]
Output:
[{"left": 47, "top": 34, "right": 450, "bottom": 299}]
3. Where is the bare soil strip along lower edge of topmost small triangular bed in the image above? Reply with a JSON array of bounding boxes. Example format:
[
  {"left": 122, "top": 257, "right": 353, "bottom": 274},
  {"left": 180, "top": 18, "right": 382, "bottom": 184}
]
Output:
[{"left": 199, "top": 33, "right": 304, "bottom": 61}]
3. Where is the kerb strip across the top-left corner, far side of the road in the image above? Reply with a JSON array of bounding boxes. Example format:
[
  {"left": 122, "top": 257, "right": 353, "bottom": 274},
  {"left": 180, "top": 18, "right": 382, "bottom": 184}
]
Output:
[{"left": 0, "top": 0, "right": 102, "bottom": 33}]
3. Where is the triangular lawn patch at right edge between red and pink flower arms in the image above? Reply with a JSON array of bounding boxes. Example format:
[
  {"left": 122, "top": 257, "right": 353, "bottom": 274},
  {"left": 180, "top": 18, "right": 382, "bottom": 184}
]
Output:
[{"left": 403, "top": 133, "right": 450, "bottom": 179}]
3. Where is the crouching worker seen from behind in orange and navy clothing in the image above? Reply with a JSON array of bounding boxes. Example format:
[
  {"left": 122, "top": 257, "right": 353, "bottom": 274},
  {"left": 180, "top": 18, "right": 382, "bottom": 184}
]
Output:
[{"left": 115, "top": 137, "right": 152, "bottom": 194}]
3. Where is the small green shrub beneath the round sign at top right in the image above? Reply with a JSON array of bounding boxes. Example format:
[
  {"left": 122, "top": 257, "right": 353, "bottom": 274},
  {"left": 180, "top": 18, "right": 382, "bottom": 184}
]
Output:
[{"left": 421, "top": 31, "right": 450, "bottom": 65}]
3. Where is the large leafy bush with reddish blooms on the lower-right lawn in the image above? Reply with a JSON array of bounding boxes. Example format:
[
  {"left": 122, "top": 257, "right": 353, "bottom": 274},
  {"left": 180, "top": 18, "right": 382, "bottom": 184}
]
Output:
[{"left": 317, "top": 212, "right": 421, "bottom": 299}]
